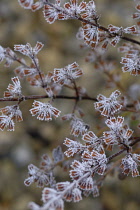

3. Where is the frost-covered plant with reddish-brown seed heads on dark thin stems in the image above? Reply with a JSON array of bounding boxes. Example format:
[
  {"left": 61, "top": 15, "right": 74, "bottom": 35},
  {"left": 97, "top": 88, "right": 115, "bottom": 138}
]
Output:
[{"left": 0, "top": 0, "right": 140, "bottom": 210}]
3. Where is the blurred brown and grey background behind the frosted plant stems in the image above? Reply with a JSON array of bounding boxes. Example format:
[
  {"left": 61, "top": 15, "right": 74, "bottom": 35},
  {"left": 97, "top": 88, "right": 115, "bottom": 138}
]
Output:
[{"left": 0, "top": 0, "right": 140, "bottom": 210}]
